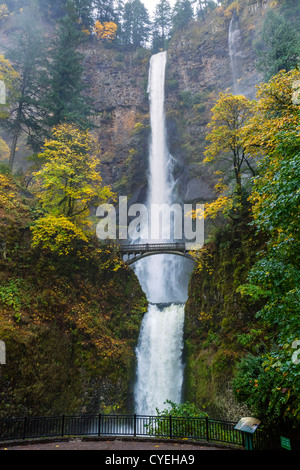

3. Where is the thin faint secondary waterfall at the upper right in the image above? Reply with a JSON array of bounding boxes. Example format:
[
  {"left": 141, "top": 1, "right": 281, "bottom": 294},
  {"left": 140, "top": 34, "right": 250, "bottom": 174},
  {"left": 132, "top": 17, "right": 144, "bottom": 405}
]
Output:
[{"left": 228, "top": 13, "right": 243, "bottom": 95}]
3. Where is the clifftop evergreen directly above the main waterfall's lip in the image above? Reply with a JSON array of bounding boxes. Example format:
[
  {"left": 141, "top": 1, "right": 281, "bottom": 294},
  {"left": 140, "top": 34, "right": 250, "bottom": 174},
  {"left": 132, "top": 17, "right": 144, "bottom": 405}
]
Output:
[{"left": 152, "top": 0, "right": 172, "bottom": 52}]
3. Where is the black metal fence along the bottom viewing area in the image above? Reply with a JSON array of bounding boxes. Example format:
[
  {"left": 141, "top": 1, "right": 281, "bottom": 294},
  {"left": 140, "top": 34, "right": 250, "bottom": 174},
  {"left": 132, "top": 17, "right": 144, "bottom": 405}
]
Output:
[{"left": 0, "top": 414, "right": 273, "bottom": 449}]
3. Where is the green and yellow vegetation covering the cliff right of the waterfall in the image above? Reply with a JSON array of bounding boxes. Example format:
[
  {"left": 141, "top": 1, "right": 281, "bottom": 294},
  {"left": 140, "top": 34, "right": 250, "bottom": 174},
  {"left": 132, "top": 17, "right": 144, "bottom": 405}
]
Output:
[{"left": 187, "top": 66, "right": 300, "bottom": 434}]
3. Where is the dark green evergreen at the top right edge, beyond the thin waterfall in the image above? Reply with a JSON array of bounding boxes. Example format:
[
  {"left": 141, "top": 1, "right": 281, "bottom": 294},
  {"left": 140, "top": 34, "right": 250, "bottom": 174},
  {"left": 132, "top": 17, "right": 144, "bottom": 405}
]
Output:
[{"left": 256, "top": 10, "right": 300, "bottom": 81}]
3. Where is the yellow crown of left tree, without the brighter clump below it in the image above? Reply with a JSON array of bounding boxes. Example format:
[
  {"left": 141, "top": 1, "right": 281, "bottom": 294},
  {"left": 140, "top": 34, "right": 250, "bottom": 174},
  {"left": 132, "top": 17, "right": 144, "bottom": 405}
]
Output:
[{"left": 34, "top": 124, "right": 113, "bottom": 225}]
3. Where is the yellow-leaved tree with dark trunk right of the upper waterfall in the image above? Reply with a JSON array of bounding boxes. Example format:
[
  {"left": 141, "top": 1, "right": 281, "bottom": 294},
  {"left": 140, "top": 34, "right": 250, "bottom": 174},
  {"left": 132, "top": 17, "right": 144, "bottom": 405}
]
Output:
[{"left": 196, "top": 93, "right": 255, "bottom": 222}]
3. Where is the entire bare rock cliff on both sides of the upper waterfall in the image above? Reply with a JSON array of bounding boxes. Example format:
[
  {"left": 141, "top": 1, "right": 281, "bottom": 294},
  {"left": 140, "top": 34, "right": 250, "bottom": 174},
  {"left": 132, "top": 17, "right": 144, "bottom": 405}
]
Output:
[{"left": 85, "top": 0, "right": 270, "bottom": 206}]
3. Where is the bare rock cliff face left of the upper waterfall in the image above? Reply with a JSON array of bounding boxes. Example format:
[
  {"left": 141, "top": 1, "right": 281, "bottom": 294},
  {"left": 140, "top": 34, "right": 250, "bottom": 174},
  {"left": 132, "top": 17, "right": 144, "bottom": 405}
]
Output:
[{"left": 84, "top": 43, "right": 150, "bottom": 204}]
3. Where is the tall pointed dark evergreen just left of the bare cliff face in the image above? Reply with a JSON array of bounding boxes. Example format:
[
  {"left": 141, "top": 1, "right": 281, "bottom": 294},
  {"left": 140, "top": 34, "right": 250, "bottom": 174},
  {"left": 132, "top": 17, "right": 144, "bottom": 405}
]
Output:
[{"left": 44, "top": 4, "right": 92, "bottom": 129}]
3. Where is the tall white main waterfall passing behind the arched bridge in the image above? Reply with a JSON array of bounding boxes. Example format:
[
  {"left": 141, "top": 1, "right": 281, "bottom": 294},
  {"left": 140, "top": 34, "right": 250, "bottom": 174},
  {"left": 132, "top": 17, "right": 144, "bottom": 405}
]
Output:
[{"left": 135, "top": 52, "right": 192, "bottom": 415}]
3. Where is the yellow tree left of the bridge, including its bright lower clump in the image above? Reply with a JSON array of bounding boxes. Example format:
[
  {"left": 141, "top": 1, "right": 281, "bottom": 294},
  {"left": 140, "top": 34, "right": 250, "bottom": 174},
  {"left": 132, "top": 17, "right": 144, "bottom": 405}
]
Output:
[{"left": 32, "top": 124, "right": 113, "bottom": 255}]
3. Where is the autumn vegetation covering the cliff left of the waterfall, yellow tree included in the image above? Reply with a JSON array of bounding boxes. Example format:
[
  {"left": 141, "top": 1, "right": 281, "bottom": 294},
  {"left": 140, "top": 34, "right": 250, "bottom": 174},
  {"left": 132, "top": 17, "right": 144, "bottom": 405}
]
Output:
[{"left": 0, "top": 125, "right": 147, "bottom": 416}]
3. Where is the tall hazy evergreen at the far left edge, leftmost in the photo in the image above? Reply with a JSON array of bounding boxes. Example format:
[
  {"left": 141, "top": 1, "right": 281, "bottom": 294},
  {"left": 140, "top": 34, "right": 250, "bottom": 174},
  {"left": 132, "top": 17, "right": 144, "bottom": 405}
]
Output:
[{"left": 2, "top": 5, "right": 45, "bottom": 168}]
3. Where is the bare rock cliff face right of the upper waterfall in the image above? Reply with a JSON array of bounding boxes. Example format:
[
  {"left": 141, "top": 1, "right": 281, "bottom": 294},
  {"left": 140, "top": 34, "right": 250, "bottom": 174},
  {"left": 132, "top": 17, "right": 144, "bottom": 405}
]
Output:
[{"left": 167, "top": 1, "right": 270, "bottom": 206}]
